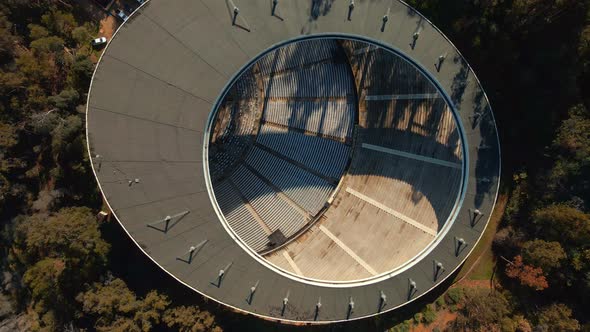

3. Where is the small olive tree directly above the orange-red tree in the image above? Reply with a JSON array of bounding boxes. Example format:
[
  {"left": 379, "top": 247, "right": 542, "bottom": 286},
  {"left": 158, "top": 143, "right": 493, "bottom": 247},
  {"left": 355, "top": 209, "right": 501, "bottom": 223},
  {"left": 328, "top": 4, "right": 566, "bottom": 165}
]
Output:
[{"left": 522, "top": 239, "right": 566, "bottom": 272}]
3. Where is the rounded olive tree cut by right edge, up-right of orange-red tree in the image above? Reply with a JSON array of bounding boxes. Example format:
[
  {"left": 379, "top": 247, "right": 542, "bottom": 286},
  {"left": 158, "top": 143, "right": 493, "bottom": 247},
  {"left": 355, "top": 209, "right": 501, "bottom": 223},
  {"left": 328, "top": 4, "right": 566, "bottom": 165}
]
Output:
[{"left": 533, "top": 204, "right": 590, "bottom": 248}]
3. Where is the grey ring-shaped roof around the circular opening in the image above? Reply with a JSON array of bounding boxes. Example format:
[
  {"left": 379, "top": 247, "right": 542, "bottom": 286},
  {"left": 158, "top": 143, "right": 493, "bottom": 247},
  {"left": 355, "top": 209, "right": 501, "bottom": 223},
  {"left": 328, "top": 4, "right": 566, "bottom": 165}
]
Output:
[{"left": 87, "top": 0, "right": 500, "bottom": 322}]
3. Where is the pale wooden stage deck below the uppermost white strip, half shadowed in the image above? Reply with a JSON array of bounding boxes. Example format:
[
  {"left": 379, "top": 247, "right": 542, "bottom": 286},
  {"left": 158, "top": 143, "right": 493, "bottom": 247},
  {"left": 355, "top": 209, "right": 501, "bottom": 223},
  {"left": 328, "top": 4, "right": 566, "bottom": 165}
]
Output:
[{"left": 266, "top": 79, "right": 462, "bottom": 281}]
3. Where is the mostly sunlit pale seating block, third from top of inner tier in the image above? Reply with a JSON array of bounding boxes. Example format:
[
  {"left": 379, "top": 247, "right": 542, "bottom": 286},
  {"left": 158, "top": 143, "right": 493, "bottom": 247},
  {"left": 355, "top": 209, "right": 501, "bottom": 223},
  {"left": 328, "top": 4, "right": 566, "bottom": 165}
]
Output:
[{"left": 263, "top": 101, "right": 355, "bottom": 138}]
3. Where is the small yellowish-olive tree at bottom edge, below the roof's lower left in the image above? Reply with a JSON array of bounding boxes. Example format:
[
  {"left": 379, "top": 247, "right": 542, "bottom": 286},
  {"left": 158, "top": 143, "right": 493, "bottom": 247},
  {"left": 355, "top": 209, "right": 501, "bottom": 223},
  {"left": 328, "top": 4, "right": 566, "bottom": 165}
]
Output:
[{"left": 163, "top": 306, "right": 221, "bottom": 332}]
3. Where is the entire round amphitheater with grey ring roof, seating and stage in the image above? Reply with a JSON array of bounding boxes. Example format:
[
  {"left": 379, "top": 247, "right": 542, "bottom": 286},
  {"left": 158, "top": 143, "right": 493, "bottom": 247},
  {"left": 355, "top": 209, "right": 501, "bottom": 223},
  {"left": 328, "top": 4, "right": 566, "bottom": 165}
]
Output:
[{"left": 87, "top": 0, "right": 500, "bottom": 323}]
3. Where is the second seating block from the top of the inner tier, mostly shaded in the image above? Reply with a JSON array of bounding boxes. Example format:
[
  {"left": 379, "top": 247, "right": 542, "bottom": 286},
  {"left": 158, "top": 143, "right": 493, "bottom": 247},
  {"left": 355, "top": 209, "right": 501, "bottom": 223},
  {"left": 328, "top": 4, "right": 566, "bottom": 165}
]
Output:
[{"left": 264, "top": 63, "right": 353, "bottom": 98}]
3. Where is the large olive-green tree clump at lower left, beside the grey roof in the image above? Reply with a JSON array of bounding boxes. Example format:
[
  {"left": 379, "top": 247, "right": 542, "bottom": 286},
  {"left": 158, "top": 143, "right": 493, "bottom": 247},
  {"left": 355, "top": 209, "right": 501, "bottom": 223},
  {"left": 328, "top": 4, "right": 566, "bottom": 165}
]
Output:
[{"left": 12, "top": 208, "right": 109, "bottom": 314}]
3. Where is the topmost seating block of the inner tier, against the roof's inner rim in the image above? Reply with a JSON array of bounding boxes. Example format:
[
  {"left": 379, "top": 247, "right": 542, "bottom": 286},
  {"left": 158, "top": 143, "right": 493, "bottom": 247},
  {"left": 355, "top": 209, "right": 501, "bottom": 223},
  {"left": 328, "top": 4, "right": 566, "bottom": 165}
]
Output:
[{"left": 258, "top": 39, "right": 338, "bottom": 75}]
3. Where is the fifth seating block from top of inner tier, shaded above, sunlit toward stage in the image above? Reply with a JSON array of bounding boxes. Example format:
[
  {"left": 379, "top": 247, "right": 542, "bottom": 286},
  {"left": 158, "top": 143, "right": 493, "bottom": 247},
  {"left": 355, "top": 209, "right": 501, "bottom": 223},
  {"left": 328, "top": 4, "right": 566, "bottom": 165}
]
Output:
[{"left": 246, "top": 147, "right": 334, "bottom": 215}]
